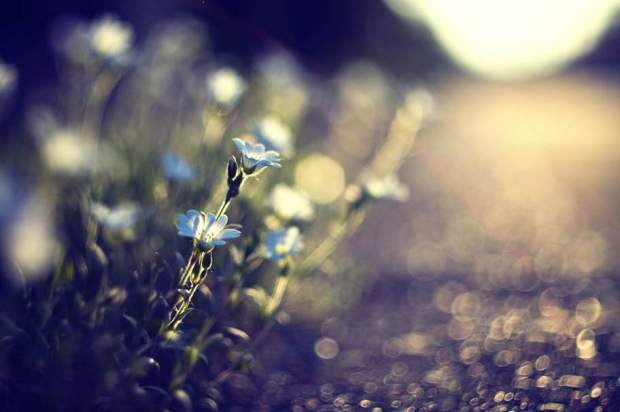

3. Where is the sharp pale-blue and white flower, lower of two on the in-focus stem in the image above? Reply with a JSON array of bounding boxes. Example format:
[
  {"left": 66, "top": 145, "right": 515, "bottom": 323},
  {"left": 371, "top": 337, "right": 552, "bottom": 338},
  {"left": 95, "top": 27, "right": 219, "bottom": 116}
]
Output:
[{"left": 176, "top": 209, "right": 241, "bottom": 248}]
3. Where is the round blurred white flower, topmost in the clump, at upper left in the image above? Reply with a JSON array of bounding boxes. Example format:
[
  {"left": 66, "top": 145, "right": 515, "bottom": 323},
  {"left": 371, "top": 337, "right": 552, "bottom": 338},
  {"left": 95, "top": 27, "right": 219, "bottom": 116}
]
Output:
[{"left": 89, "top": 16, "right": 133, "bottom": 59}]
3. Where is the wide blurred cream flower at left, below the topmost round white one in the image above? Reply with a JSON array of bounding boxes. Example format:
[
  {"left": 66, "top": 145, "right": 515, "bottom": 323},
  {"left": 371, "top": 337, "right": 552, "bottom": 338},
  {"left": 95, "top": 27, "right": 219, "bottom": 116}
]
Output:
[{"left": 42, "top": 128, "right": 111, "bottom": 174}]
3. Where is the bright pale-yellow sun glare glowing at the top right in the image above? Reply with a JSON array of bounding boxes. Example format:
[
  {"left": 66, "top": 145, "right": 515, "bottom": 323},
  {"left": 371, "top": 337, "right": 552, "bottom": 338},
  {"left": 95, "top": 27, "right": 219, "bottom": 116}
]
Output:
[{"left": 385, "top": 0, "right": 619, "bottom": 79}]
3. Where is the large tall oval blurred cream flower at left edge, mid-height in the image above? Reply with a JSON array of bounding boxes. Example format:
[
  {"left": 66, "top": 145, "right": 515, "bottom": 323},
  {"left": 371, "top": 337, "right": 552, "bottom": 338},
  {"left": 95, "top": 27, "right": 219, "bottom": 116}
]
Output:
[{"left": 3, "top": 196, "right": 57, "bottom": 284}]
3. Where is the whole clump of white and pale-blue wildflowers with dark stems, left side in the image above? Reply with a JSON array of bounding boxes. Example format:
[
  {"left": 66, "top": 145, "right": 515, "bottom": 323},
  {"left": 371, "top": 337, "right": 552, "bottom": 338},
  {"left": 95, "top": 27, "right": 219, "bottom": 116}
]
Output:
[{"left": 0, "top": 16, "right": 426, "bottom": 411}]
